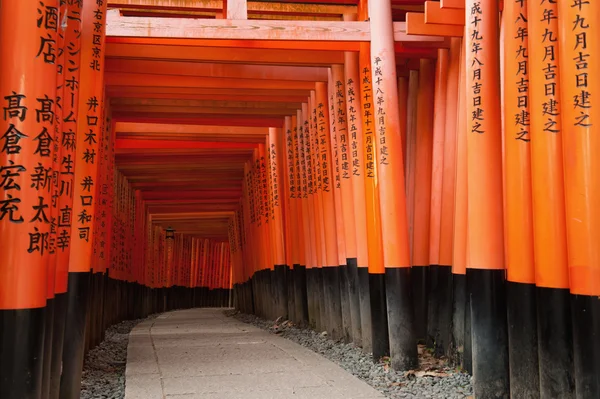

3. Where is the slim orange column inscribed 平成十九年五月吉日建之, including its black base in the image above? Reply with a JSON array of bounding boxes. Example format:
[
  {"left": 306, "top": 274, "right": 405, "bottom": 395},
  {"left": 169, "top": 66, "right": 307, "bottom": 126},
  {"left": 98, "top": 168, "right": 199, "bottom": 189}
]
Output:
[{"left": 344, "top": 51, "right": 372, "bottom": 353}]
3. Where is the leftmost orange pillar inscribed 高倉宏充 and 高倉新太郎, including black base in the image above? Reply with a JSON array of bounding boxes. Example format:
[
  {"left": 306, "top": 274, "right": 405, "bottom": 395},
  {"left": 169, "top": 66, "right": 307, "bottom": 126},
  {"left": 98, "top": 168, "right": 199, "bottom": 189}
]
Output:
[{"left": 0, "top": 1, "right": 59, "bottom": 399}]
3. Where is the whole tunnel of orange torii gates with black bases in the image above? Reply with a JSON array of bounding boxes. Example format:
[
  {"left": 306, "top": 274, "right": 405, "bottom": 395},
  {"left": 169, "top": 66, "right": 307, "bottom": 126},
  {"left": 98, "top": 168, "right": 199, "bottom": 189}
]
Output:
[{"left": 0, "top": 0, "right": 600, "bottom": 399}]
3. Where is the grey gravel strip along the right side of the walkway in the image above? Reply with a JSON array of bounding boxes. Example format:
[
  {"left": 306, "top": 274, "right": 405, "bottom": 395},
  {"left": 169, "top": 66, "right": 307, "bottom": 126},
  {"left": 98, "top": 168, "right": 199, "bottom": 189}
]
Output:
[{"left": 225, "top": 310, "right": 473, "bottom": 399}]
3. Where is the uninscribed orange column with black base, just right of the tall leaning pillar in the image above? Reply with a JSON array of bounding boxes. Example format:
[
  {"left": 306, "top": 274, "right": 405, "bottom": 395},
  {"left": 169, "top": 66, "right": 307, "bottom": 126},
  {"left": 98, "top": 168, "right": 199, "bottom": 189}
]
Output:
[{"left": 408, "top": 59, "right": 436, "bottom": 340}]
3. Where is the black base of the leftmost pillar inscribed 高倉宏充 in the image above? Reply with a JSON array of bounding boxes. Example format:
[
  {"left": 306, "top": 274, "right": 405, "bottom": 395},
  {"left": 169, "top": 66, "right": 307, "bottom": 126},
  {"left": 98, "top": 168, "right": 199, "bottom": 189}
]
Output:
[{"left": 0, "top": 308, "right": 46, "bottom": 399}]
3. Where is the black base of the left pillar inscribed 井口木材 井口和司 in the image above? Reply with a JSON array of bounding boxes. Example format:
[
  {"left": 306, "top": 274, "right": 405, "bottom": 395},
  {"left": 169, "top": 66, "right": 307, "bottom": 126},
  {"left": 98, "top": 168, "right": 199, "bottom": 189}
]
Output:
[{"left": 59, "top": 272, "right": 90, "bottom": 399}]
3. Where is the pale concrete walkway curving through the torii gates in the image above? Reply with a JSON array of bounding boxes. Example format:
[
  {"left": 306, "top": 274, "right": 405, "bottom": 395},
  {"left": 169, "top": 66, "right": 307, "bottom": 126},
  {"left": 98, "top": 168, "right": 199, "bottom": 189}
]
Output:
[{"left": 125, "top": 309, "right": 384, "bottom": 399}]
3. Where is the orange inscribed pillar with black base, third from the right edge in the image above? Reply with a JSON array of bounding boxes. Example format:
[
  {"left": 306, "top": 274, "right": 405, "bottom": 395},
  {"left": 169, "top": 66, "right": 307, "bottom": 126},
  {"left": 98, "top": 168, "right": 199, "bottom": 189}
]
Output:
[{"left": 502, "top": 2, "right": 540, "bottom": 397}]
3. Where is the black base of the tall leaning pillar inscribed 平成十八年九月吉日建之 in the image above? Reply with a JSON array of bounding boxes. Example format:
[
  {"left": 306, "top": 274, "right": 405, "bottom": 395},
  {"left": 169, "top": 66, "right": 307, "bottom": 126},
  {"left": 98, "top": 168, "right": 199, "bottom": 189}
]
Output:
[{"left": 385, "top": 267, "right": 419, "bottom": 370}]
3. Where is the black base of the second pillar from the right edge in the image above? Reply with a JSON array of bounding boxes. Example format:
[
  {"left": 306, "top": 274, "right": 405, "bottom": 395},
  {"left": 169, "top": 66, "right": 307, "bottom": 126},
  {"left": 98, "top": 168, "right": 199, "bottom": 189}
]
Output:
[{"left": 537, "top": 287, "right": 575, "bottom": 398}]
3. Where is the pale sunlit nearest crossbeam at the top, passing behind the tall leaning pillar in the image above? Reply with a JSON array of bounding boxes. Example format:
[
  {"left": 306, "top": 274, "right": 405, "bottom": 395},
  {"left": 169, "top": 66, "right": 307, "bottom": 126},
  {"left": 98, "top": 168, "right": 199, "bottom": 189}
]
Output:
[{"left": 106, "top": 10, "right": 446, "bottom": 42}]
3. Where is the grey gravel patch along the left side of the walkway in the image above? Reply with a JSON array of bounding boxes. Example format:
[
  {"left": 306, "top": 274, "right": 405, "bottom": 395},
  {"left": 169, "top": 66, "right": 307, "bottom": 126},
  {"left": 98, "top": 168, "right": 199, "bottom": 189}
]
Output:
[{"left": 80, "top": 315, "right": 156, "bottom": 399}]
